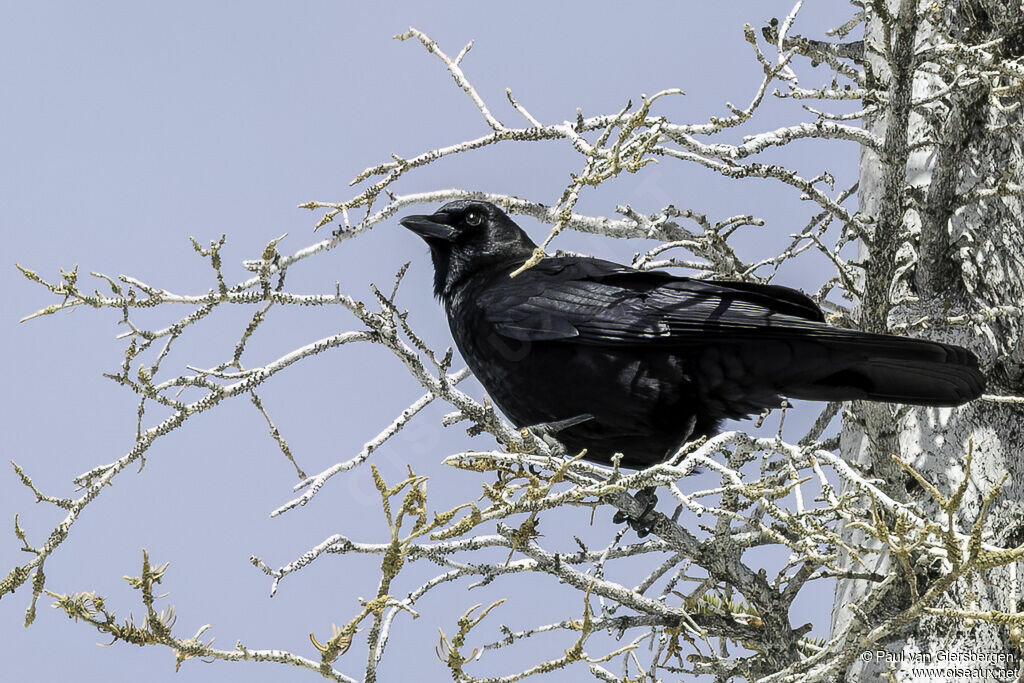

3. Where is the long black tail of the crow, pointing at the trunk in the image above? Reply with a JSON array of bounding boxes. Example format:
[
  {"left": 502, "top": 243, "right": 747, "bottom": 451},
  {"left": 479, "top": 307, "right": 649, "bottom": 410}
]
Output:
[{"left": 780, "top": 328, "right": 985, "bottom": 405}]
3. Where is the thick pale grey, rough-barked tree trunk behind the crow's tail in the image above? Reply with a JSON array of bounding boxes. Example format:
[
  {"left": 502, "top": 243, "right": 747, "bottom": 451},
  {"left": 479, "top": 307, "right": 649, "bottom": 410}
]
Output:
[{"left": 833, "top": 0, "right": 1024, "bottom": 681}]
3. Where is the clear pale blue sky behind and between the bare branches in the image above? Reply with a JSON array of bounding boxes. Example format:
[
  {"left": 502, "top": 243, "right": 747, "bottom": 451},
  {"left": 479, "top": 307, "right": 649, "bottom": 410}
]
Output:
[{"left": 0, "top": 0, "right": 857, "bottom": 683}]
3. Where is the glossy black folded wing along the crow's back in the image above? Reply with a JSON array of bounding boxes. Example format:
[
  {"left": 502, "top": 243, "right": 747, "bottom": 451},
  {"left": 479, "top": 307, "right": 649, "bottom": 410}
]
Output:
[{"left": 477, "top": 257, "right": 831, "bottom": 346}]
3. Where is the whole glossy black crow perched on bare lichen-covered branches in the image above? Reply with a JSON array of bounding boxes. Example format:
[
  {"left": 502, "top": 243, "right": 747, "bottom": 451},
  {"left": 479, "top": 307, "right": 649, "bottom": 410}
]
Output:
[{"left": 401, "top": 201, "right": 985, "bottom": 468}]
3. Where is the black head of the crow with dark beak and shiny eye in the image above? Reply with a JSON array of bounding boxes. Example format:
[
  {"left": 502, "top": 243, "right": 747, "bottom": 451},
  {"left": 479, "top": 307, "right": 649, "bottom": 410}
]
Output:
[{"left": 401, "top": 200, "right": 537, "bottom": 298}]
